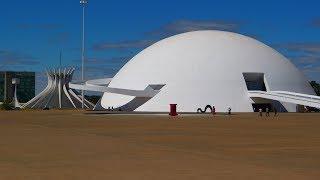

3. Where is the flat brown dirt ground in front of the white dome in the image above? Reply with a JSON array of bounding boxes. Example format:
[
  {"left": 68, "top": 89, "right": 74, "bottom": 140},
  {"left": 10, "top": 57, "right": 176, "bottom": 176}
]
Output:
[{"left": 0, "top": 111, "right": 320, "bottom": 180}]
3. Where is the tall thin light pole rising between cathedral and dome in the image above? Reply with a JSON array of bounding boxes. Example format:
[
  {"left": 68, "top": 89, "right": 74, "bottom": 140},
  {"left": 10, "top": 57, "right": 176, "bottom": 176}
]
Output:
[{"left": 80, "top": 0, "right": 88, "bottom": 109}]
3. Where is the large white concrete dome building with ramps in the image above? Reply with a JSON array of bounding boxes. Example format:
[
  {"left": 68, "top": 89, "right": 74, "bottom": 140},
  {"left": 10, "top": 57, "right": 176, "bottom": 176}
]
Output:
[{"left": 83, "top": 31, "right": 320, "bottom": 112}]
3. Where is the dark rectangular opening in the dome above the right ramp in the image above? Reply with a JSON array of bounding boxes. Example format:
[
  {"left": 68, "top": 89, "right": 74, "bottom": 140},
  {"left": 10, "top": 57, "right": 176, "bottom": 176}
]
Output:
[{"left": 243, "top": 73, "right": 267, "bottom": 91}]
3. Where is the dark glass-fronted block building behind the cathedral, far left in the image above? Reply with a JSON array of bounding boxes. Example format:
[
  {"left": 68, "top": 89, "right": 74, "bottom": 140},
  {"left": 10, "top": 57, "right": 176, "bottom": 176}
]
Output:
[{"left": 0, "top": 71, "right": 35, "bottom": 103}]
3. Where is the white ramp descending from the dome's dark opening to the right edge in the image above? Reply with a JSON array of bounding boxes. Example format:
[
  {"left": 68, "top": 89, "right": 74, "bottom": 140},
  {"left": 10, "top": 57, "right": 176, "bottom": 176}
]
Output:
[{"left": 248, "top": 91, "right": 320, "bottom": 109}]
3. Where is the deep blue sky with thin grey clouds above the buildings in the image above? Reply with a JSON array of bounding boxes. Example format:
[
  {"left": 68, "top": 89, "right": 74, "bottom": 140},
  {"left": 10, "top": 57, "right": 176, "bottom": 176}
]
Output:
[{"left": 0, "top": 0, "right": 320, "bottom": 91}]
